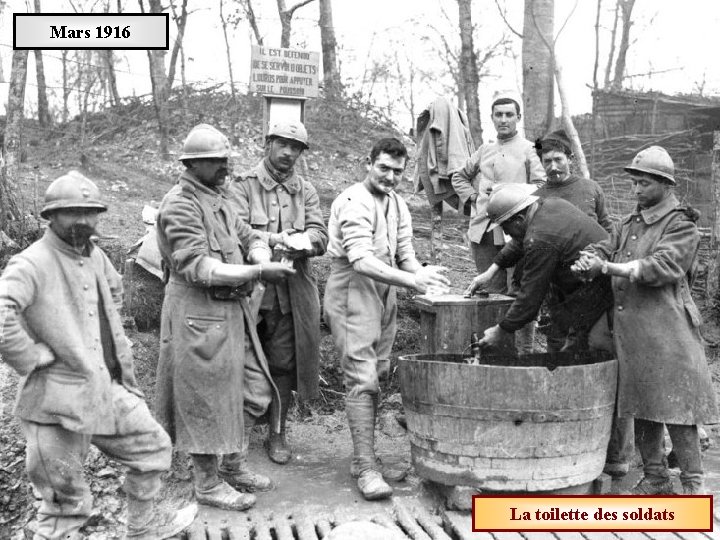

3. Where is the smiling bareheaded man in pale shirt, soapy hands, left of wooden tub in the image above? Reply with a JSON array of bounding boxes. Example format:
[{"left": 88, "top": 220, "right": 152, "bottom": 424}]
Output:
[{"left": 324, "top": 138, "right": 450, "bottom": 500}]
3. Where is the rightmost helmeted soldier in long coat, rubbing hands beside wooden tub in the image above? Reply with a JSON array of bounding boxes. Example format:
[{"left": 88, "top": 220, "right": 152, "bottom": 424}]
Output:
[{"left": 573, "top": 146, "right": 719, "bottom": 495}]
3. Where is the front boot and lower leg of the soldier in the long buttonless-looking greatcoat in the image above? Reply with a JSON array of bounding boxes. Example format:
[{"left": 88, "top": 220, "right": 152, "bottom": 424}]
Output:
[{"left": 190, "top": 454, "right": 255, "bottom": 511}]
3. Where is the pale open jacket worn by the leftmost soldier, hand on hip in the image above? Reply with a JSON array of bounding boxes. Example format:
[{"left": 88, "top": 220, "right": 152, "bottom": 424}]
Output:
[{"left": 0, "top": 229, "right": 142, "bottom": 435}]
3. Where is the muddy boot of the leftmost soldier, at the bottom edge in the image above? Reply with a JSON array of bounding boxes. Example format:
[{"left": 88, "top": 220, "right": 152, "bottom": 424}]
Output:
[{"left": 125, "top": 496, "right": 197, "bottom": 540}]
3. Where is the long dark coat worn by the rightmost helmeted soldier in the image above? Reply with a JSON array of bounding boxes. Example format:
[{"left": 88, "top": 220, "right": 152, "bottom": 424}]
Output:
[{"left": 590, "top": 194, "right": 718, "bottom": 425}]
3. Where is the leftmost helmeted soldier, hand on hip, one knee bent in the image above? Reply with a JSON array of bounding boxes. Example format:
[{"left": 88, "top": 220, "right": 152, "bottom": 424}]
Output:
[{"left": 0, "top": 171, "right": 197, "bottom": 539}]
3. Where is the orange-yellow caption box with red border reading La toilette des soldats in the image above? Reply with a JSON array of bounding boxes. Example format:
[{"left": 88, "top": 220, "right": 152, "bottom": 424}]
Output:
[{"left": 472, "top": 495, "right": 713, "bottom": 532}]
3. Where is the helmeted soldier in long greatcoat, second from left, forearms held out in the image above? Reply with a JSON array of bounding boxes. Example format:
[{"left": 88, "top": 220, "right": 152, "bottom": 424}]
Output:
[{"left": 157, "top": 124, "right": 295, "bottom": 510}]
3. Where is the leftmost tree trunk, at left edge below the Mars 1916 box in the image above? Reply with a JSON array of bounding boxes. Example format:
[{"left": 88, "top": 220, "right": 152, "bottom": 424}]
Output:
[{"left": 0, "top": 50, "right": 28, "bottom": 233}]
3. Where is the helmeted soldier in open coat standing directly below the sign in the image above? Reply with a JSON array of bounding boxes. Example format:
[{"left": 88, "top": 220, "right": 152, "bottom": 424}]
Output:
[{"left": 232, "top": 121, "right": 328, "bottom": 464}]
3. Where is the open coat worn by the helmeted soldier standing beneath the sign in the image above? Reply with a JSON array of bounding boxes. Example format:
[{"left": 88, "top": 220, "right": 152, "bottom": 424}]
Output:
[{"left": 231, "top": 162, "right": 328, "bottom": 399}]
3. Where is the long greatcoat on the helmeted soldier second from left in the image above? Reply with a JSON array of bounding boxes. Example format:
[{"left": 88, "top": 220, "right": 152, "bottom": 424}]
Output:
[{"left": 156, "top": 171, "right": 276, "bottom": 454}]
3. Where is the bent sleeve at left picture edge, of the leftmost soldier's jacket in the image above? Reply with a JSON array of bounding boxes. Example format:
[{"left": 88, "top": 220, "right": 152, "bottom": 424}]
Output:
[{"left": 0, "top": 257, "right": 47, "bottom": 375}]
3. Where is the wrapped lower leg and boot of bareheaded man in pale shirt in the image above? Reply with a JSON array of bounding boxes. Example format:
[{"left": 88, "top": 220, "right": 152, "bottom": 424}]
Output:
[{"left": 345, "top": 394, "right": 393, "bottom": 501}]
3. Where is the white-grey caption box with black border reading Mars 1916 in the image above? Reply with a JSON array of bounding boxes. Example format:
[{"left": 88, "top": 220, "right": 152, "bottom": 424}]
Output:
[{"left": 13, "top": 13, "right": 170, "bottom": 50}]
